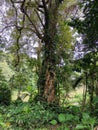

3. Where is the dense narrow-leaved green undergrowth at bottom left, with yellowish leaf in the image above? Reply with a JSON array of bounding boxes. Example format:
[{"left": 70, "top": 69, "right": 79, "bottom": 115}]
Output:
[{"left": 0, "top": 103, "right": 55, "bottom": 130}]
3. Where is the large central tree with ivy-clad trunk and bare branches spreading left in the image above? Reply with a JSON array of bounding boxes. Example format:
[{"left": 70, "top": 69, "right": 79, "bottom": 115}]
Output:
[{"left": 0, "top": 0, "right": 76, "bottom": 104}]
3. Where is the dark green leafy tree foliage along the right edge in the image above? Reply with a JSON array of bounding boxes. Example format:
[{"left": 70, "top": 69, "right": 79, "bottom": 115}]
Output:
[{"left": 72, "top": 0, "right": 98, "bottom": 108}]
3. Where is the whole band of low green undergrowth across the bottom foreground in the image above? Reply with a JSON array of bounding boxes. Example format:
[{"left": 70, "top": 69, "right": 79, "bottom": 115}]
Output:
[{"left": 0, "top": 102, "right": 97, "bottom": 130}]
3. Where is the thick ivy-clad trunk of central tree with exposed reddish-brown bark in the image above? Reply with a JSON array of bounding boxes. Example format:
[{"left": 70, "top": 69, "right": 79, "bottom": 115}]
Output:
[{"left": 38, "top": 3, "right": 58, "bottom": 104}]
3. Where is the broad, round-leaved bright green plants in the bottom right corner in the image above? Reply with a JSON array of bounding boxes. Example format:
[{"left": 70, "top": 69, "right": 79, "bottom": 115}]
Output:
[{"left": 50, "top": 106, "right": 97, "bottom": 130}]
